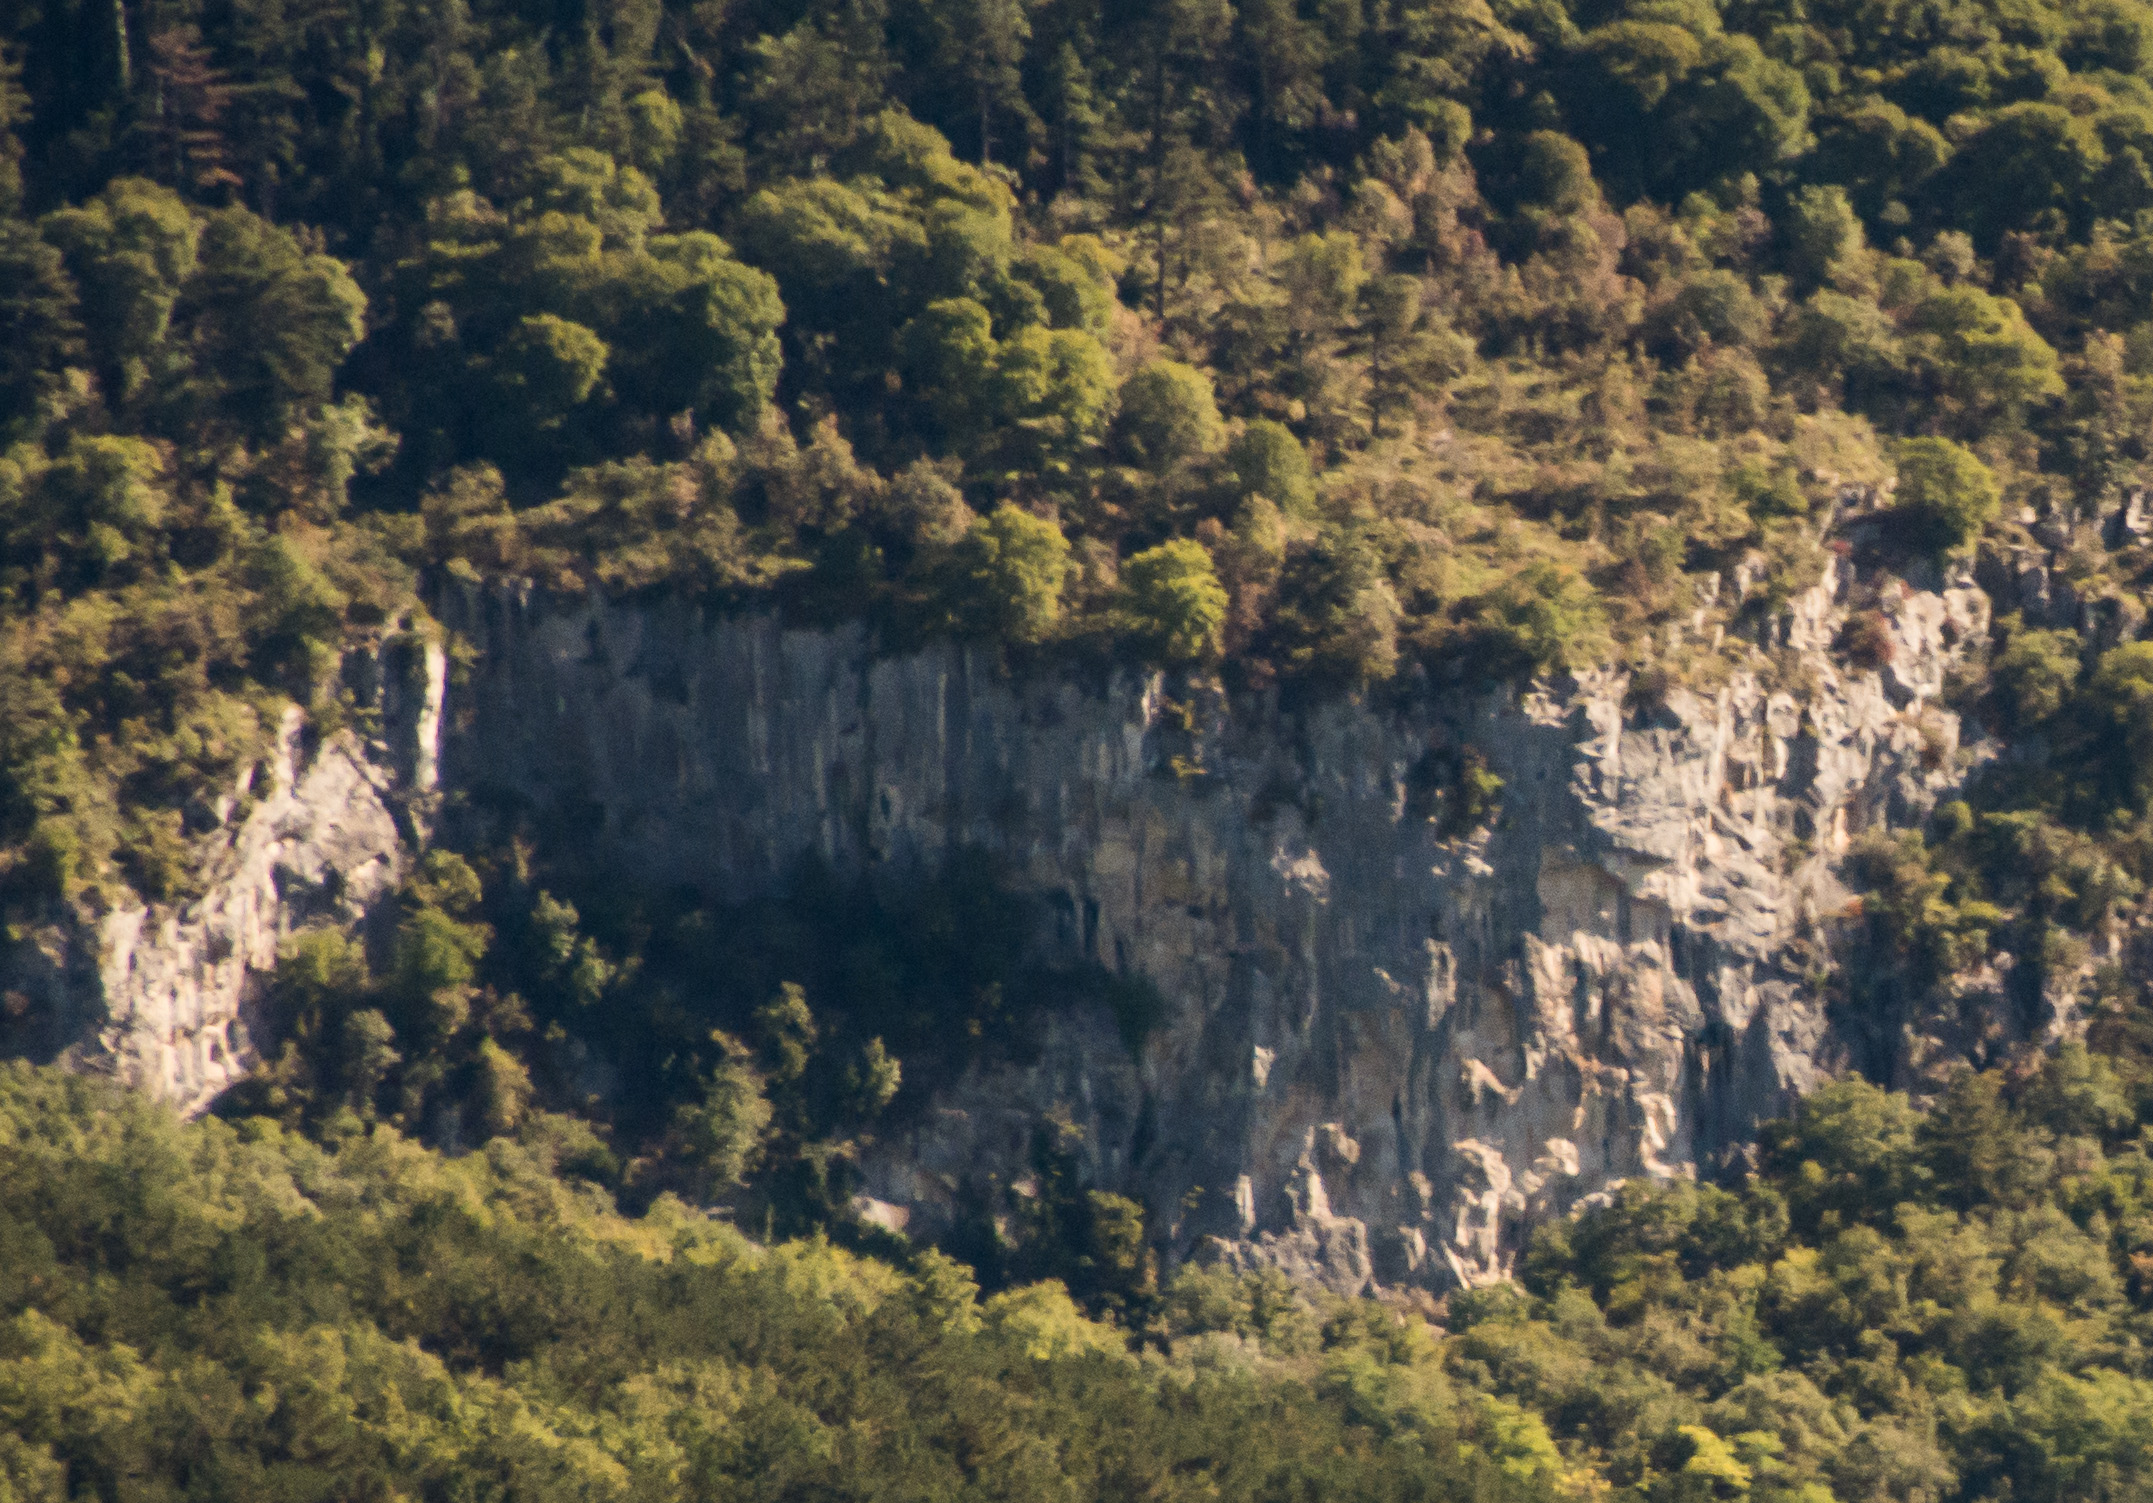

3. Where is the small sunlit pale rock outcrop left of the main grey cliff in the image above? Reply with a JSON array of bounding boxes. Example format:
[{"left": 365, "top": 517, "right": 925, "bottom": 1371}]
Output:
[{"left": 0, "top": 637, "right": 446, "bottom": 1113}]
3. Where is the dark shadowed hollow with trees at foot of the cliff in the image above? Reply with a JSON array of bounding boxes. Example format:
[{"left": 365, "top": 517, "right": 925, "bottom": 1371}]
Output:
[{"left": 220, "top": 831, "right": 1165, "bottom": 1236}]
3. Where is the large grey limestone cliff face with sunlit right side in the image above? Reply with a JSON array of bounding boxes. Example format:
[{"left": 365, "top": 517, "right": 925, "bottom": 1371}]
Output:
[{"left": 441, "top": 555, "right": 1997, "bottom": 1290}]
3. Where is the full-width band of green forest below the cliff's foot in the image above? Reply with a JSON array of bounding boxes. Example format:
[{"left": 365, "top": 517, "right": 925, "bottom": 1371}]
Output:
[{"left": 16, "top": 1047, "right": 2153, "bottom": 1503}]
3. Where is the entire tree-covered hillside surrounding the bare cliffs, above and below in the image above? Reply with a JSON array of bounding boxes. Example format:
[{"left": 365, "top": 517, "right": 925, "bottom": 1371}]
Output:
[{"left": 0, "top": 0, "right": 2153, "bottom": 1503}]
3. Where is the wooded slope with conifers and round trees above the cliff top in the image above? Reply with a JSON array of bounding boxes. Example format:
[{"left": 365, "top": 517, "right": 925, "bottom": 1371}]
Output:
[{"left": 12, "top": 0, "right": 2153, "bottom": 928}]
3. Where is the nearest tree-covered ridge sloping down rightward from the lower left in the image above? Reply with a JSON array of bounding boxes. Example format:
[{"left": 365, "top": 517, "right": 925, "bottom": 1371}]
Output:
[{"left": 0, "top": 1066, "right": 1563, "bottom": 1503}]
